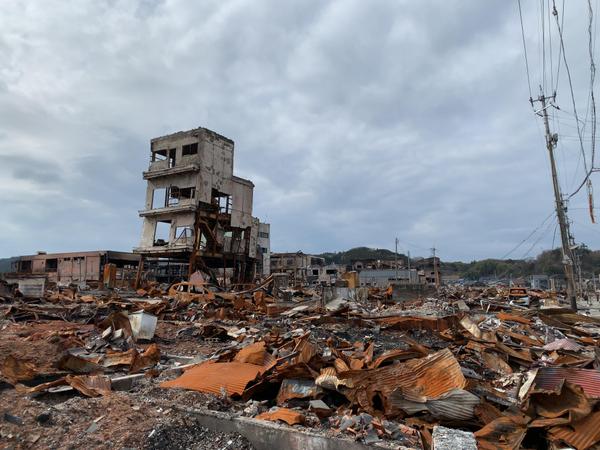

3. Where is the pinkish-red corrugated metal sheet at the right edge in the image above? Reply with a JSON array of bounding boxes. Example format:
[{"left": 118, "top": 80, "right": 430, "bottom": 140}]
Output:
[{"left": 534, "top": 367, "right": 600, "bottom": 399}]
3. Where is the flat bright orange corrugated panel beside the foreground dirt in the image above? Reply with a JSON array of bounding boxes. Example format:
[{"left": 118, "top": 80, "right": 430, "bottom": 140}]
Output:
[{"left": 160, "top": 362, "right": 263, "bottom": 395}]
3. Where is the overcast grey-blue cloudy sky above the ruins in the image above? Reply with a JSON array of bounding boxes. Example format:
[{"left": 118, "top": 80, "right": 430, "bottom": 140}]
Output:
[{"left": 0, "top": 0, "right": 600, "bottom": 260}]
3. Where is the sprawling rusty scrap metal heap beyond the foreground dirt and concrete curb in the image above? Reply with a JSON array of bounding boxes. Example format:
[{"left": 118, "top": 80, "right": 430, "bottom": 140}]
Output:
[{"left": 5, "top": 281, "right": 600, "bottom": 449}]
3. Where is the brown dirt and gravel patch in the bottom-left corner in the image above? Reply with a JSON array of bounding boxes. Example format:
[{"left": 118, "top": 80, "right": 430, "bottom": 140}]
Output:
[{"left": 0, "top": 380, "right": 252, "bottom": 450}]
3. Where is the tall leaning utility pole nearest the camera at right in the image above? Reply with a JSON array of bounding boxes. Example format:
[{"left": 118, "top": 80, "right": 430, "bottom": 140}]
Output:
[{"left": 537, "top": 89, "right": 577, "bottom": 311}]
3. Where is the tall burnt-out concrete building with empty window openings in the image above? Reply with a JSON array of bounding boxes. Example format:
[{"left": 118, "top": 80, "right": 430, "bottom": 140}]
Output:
[{"left": 134, "top": 128, "right": 270, "bottom": 283}]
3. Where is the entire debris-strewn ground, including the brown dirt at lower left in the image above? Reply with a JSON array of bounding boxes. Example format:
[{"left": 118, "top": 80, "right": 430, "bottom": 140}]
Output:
[{"left": 0, "top": 278, "right": 600, "bottom": 449}]
